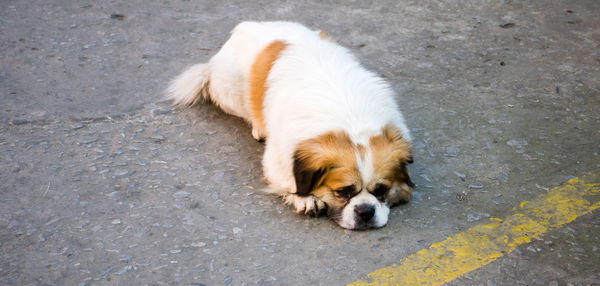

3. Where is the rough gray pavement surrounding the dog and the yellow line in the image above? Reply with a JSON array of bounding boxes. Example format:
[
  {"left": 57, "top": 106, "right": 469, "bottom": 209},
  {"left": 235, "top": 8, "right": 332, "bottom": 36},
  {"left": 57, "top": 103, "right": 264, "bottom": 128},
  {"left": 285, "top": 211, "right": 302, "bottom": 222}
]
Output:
[{"left": 0, "top": 0, "right": 600, "bottom": 285}]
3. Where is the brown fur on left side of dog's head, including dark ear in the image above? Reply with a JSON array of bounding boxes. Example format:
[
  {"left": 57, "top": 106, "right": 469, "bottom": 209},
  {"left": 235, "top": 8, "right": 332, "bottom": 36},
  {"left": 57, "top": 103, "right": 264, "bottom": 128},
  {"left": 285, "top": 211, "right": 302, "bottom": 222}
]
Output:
[{"left": 294, "top": 131, "right": 360, "bottom": 195}]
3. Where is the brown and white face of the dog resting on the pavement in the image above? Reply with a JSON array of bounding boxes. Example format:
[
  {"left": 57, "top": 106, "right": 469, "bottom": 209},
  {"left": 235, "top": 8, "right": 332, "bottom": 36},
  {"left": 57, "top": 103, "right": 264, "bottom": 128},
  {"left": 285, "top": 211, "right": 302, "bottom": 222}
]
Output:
[{"left": 294, "top": 125, "right": 414, "bottom": 229}]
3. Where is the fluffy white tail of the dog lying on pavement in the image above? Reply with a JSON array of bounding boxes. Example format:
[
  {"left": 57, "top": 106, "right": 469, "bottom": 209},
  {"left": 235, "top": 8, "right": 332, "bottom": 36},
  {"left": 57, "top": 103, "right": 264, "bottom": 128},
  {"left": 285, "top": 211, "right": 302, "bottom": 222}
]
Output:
[{"left": 165, "top": 63, "right": 210, "bottom": 106}]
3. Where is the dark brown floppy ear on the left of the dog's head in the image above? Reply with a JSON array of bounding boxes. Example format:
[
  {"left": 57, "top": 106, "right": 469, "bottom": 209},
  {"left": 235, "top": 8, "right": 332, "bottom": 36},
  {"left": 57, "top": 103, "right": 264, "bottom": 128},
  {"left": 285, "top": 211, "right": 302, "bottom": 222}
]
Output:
[{"left": 294, "top": 152, "right": 327, "bottom": 196}]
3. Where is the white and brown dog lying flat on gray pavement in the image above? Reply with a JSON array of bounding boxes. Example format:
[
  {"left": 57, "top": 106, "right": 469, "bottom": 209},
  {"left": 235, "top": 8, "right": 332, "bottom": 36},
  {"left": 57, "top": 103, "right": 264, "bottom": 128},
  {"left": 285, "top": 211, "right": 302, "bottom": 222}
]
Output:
[{"left": 166, "top": 22, "right": 414, "bottom": 229}]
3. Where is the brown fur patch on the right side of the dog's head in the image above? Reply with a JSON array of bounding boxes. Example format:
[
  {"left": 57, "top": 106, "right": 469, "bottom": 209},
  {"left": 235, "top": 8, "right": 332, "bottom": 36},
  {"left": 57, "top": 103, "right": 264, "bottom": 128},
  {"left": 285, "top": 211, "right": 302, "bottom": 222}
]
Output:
[{"left": 369, "top": 125, "right": 413, "bottom": 205}]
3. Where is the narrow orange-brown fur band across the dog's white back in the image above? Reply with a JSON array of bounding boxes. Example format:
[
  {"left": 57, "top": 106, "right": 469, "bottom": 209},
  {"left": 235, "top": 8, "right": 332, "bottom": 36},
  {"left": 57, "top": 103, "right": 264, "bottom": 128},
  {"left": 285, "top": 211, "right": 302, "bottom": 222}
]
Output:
[{"left": 249, "top": 41, "right": 287, "bottom": 136}]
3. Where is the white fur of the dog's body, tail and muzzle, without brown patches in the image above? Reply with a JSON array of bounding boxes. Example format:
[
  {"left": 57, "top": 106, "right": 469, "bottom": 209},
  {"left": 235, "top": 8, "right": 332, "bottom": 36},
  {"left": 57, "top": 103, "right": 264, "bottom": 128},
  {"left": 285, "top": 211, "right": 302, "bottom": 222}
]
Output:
[{"left": 168, "top": 22, "right": 411, "bottom": 228}]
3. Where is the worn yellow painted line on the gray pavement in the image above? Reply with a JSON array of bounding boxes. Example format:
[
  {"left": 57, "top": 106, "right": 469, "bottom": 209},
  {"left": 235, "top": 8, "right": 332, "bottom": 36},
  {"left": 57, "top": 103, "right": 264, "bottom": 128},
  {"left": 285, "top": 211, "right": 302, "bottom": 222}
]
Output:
[{"left": 349, "top": 175, "right": 600, "bottom": 286}]
